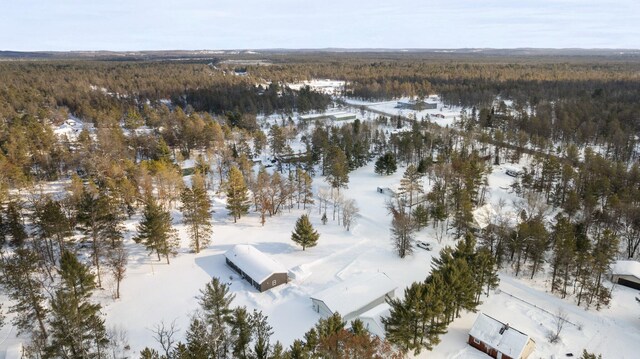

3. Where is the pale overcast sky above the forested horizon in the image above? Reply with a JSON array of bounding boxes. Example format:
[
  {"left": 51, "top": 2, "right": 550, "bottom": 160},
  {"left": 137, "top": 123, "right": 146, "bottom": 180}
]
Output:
[{"left": 0, "top": 0, "right": 640, "bottom": 51}]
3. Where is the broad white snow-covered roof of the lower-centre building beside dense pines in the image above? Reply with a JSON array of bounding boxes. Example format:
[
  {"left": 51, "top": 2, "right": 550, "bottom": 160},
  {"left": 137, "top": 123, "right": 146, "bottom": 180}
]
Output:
[{"left": 311, "top": 272, "right": 397, "bottom": 317}]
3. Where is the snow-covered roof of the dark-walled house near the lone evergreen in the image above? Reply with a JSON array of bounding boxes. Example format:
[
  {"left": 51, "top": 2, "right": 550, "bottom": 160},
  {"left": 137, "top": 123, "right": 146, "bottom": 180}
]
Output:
[{"left": 224, "top": 244, "right": 287, "bottom": 282}]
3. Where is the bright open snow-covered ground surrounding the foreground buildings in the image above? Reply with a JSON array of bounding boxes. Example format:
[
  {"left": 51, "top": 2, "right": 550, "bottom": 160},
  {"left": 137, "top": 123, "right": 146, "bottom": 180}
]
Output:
[{"left": 67, "top": 160, "right": 640, "bottom": 358}]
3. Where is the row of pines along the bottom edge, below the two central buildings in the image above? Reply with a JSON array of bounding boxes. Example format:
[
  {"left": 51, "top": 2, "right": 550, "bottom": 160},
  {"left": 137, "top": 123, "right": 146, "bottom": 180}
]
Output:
[{"left": 140, "top": 278, "right": 402, "bottom": 359}]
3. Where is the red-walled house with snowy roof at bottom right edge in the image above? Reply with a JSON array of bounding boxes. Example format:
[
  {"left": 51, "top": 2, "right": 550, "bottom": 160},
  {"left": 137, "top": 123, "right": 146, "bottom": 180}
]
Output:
[{"left": 468, "top": 313, "right": 536, "bottom": 359}]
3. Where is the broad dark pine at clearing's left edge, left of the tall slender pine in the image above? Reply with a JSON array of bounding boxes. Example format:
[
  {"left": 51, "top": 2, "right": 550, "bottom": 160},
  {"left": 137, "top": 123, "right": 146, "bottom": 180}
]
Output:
[{"left": 133, "top": 196, "right": 178, "bottom": 264}]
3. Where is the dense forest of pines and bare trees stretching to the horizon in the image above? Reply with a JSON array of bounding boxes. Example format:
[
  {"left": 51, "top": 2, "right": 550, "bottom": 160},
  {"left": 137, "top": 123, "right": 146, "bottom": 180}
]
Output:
[{"left": 0, "top": 54, "right": 640, "bottom": 358}]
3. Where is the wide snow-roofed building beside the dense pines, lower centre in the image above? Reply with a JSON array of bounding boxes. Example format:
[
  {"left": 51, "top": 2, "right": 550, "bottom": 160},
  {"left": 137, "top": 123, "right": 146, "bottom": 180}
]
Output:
[{"left": 311, "top": 272, "right": 397, "bottom": 322}]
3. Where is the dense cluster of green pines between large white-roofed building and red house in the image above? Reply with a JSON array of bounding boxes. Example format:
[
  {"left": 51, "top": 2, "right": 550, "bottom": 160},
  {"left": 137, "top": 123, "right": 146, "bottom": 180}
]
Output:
[{"left": 383, "top": 235, "right": 499, "bottom": 355}]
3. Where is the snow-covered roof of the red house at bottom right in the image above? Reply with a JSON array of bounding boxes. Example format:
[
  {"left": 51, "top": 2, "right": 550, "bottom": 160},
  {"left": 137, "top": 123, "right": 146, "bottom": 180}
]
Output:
[{"left": 469, "top": 313, "right": 529, "bottom": 358}]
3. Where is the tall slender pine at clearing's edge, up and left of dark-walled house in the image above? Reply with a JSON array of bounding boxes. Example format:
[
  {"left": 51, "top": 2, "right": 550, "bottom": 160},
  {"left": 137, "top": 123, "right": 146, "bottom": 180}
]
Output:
[{"left": 180, "top": 173, "right": 212, "bottom": 253}]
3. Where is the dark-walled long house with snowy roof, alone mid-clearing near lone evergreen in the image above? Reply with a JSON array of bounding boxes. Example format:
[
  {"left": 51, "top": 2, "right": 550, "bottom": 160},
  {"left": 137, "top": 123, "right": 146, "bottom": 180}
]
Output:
[{"left": 224, "top": 244, "right": 289, "bottom": 292}]
